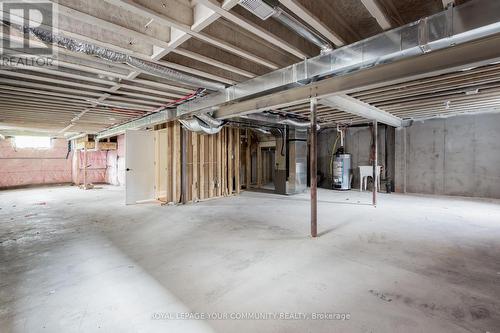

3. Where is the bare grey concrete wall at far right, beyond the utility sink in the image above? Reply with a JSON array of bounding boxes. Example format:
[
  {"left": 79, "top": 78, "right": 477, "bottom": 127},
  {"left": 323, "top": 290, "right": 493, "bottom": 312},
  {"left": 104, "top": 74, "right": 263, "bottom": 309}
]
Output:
[{"left": 396, "top": 113, "right": 500, "bottom": 198}]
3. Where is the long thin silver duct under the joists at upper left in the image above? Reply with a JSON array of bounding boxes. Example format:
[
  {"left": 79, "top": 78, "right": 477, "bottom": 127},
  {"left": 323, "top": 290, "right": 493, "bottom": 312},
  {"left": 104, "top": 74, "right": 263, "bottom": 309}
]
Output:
[{"left": 17, "top": 24, "right": 225, "bottom": 91}]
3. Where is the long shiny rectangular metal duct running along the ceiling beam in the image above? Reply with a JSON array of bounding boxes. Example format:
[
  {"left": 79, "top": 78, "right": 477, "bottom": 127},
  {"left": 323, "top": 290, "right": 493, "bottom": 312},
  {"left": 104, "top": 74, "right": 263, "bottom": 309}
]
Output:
[{"left": 177, "top": 0, "right": 500, "bottom": 116}]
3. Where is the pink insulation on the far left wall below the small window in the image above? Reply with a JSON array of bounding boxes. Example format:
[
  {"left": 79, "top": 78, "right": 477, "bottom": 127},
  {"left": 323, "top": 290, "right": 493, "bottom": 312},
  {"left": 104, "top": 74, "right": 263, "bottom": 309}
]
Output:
[{"left": 0, "top": 139, "right": 72, "bottom": 188}]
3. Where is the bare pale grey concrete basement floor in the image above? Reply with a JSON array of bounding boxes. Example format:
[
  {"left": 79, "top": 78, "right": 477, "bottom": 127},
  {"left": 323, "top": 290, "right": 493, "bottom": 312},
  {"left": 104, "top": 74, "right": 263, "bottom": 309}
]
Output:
[{"left": 0, "top": 187, "right": 500, "bottom": 333}]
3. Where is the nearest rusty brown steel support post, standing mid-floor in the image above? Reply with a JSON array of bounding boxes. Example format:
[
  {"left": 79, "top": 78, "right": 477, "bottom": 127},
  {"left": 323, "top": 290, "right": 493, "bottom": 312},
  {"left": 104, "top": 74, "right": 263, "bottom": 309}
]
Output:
[{"left": 309, "top": 98, "right": 318, "bottom": 237}]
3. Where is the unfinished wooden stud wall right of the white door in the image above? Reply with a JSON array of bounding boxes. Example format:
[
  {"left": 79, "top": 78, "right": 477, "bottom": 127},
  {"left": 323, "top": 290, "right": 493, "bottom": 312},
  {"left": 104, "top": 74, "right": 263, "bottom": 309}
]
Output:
[{"left": 156, "top": 122, "right": 241, "bottom": 203}]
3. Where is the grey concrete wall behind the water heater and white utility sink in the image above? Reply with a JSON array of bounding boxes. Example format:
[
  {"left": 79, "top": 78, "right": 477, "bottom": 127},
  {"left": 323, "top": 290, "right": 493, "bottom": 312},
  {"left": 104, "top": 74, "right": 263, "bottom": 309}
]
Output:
[{"left": 318, "top": 125, "right": 395, "bottom": 189}]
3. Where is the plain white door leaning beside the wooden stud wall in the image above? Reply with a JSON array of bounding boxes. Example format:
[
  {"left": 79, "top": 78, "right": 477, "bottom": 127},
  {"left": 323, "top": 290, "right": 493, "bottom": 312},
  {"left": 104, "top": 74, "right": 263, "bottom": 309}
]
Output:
[{"left": 125, "top": 130, "right": 155, "bottom": 205}]
